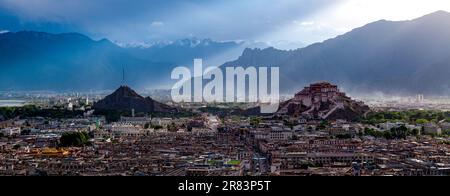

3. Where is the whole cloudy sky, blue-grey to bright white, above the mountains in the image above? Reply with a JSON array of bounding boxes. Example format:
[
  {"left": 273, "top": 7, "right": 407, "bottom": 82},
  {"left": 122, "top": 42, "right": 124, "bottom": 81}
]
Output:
[{"left": 0, "top": 0, "right": 450, "bottom": 44}]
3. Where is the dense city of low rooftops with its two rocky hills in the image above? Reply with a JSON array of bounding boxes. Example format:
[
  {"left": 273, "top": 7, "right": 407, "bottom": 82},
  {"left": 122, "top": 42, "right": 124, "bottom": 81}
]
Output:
[{"left": 0, "top": 82, "right": 450, "bottom": 176}]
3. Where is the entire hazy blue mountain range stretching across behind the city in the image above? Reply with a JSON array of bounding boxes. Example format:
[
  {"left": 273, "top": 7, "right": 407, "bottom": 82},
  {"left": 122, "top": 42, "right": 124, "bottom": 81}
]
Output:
[{"left": 0, "top": 11, "right": 450, "bottom": 95}]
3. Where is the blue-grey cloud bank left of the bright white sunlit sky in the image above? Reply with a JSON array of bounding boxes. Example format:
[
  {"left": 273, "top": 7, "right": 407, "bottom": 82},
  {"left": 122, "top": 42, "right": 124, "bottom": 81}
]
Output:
[{"left": 0, "top": 0, "right": 339, "bottom": 42}]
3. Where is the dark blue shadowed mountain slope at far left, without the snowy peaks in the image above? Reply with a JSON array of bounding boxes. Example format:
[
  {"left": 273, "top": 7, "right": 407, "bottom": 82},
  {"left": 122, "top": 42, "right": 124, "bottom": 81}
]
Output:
[{"left": 0, "top": 32, "right": 168, "bottom": 90}]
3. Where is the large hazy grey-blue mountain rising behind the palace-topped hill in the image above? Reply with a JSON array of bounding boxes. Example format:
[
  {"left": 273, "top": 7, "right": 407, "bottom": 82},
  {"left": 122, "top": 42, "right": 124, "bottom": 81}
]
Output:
[{"left": 224, "top": 11, "right": 450, "bottom": 95}]
